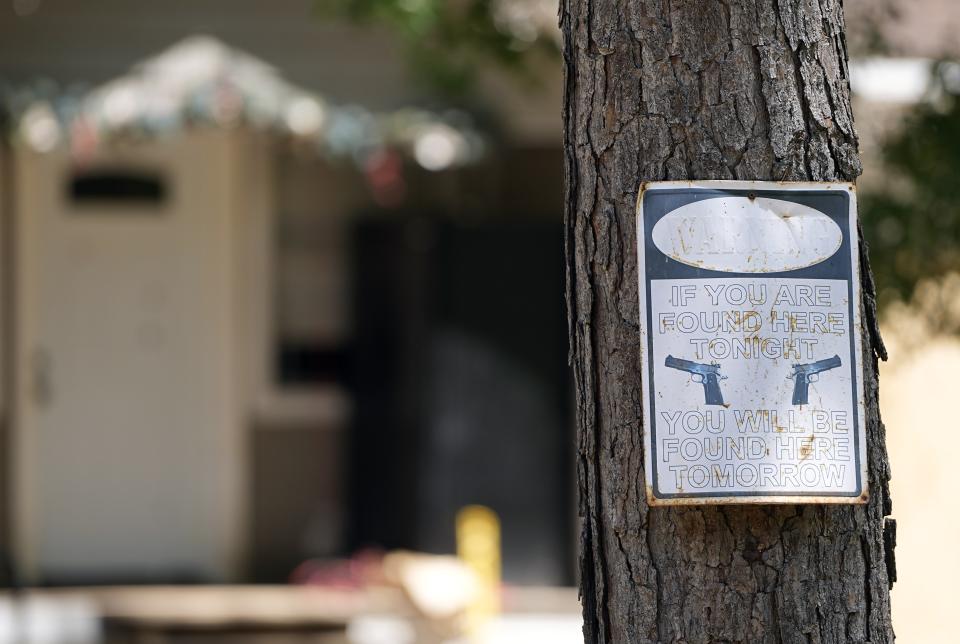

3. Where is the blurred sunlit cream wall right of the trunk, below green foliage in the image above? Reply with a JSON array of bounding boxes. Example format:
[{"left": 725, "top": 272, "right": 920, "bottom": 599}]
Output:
[{"left": 880, "top": 327, "right": 960, "bottom": 642}]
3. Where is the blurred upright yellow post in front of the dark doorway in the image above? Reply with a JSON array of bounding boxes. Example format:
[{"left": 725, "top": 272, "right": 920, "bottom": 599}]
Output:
[{"left": 457, "top": 505, "right": 500, "bottom": 638}]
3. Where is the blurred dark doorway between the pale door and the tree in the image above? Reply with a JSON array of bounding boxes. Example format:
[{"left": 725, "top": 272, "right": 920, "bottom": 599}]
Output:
[{"left": 348, "top": 219, "right": 573, "bottom": 584}]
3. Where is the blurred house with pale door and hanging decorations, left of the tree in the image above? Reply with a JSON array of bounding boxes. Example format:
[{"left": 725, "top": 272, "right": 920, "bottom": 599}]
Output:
[{"left": 0, "top": 0, "right": 574, "bottom": 585}]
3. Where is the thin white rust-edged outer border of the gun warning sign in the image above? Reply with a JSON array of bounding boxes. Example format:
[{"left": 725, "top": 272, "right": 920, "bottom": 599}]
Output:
[{"left": 635, "top": 180, "right": 869, "bottom": 506}]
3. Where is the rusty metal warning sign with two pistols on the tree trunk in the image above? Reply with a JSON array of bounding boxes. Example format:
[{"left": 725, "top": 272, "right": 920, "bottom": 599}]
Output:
[{"left": 637, "top": 181, "right": 867, "bottom": 505}]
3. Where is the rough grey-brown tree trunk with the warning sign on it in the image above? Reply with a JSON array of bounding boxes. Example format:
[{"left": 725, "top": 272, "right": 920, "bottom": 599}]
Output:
[{"left": 560, "top": 0, "right": 894, "bottom": 644}]
